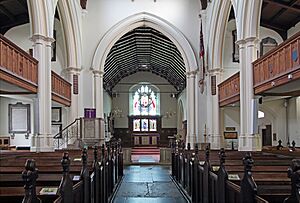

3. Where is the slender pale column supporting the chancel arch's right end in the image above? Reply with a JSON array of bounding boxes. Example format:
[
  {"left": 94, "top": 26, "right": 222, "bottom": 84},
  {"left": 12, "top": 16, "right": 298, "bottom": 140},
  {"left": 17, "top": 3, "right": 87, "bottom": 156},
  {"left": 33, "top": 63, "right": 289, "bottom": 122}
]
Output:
[{"left": 186, "top": 71, "right": 197, "bottom": 149}]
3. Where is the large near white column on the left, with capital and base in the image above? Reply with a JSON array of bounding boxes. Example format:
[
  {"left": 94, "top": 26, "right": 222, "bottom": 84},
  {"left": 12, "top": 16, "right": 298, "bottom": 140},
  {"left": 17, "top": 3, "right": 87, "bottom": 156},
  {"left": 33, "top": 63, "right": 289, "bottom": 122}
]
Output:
[{"left": 31, "top": 35, "right": 54, "bottom": 151}]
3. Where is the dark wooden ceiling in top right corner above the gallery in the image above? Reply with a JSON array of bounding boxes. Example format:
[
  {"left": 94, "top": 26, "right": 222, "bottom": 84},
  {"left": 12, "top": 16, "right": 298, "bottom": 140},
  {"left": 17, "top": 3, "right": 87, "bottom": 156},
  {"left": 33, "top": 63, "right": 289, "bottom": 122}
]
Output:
[{"left": 260, "top": 0, "right": 300, "bottom": 40}]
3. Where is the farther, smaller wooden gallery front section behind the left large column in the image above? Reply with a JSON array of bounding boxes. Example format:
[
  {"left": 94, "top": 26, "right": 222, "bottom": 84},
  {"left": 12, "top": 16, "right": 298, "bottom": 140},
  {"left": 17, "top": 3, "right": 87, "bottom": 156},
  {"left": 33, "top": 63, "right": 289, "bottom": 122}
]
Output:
[{"left": 51, "top": 71, "right": 71, "bottom": 106}]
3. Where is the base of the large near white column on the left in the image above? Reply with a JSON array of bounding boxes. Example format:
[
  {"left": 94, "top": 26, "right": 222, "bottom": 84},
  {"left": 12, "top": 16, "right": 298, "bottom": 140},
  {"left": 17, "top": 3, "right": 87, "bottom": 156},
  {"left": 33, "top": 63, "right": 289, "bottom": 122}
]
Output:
[{"left": 30, "top": 135, "right": 54, "bottom": 152}]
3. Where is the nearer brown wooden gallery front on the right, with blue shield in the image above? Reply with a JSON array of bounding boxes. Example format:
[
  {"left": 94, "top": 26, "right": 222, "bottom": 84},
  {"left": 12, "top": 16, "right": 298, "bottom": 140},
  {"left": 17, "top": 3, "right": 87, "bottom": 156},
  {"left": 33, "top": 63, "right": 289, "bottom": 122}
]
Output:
[{"left": 253, "top": 32, "right": 300, "bottom": 94}]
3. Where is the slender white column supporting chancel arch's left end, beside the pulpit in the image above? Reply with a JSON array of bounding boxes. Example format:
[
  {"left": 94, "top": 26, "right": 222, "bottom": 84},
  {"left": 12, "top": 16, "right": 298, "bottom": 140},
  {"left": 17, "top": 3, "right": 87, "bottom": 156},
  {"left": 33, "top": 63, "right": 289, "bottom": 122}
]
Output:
[{"left": 93, "top": 70, "right": 105, "bottom": 144}]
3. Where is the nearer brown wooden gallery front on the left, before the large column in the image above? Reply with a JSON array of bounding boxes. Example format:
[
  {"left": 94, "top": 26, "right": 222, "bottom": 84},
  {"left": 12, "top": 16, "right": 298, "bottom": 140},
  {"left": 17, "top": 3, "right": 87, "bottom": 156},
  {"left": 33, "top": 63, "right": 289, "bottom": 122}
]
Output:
[{"left": 0, "top": 34, "right": 38, "bottom": 93}]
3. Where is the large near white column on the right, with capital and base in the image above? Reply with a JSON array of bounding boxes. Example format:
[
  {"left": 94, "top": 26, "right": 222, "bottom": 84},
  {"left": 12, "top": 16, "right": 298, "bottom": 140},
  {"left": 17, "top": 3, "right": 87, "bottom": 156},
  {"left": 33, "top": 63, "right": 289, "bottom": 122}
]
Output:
[{"left": 237, "top": 37, "right": 261, "bottom": 151}]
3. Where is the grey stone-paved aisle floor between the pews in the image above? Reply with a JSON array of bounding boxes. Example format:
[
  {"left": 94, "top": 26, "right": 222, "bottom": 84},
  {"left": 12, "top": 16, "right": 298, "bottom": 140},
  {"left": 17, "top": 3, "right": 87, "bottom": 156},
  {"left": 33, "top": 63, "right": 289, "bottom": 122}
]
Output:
[{"left": 114, "top": 165, "right": 186, "bottom": 203}]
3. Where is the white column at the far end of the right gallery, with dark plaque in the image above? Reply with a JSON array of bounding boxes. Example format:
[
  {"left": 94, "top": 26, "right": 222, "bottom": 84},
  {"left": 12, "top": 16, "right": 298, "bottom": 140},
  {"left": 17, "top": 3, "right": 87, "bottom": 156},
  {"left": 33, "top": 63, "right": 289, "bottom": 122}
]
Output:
[{"left": 207, "top": 69, "right": 222, "bottom": 149}]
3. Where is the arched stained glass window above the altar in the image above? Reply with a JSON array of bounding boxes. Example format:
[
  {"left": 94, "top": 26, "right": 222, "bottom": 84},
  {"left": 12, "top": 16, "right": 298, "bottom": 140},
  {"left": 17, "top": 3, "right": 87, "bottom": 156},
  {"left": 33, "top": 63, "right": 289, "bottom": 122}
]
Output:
[{"left": 133, "top": 85, "right": 157, "bottom": 115}]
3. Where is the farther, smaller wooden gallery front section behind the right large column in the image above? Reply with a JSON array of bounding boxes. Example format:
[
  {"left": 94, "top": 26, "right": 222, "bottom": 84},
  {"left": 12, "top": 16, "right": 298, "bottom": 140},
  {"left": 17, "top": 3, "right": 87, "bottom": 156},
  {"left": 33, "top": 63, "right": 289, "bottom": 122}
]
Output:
[{"left": 218, "top": 72, "right": 240, "bottom": 107}]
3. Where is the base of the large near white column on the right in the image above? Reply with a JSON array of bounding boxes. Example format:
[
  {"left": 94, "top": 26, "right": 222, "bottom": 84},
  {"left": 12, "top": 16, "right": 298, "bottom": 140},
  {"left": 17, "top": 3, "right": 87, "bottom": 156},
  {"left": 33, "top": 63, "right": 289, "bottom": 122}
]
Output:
[{"left": 238, "top": 134, "right": 262, "bottom": 151}]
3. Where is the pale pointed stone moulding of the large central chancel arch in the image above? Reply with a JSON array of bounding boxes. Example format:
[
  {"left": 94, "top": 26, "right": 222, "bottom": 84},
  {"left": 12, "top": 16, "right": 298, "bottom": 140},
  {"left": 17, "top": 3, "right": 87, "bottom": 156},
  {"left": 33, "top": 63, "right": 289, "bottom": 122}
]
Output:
[{"left": 92, "top": 12, "right": 198, "bottom": 72}]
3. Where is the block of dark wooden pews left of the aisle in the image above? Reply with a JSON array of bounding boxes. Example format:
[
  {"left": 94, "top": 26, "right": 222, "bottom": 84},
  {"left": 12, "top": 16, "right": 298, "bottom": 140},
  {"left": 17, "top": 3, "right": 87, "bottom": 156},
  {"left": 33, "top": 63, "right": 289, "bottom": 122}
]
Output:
[{"left": 0, "top": 142, "right": 123, "bottom": 202}]
